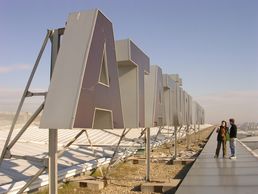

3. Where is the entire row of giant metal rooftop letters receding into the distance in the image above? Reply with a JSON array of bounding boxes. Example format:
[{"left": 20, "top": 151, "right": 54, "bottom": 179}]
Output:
[{"left": 40, "top": 10, "right": 204, "bottom": 129}]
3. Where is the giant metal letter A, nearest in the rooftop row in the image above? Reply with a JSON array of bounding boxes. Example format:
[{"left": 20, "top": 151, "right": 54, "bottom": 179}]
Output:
[{"left": 40, "top": 10, "right": 123, "bottom": 128}]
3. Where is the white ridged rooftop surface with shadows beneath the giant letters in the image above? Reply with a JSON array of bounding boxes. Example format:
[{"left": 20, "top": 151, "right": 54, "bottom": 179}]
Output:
[{"left": 0, "top": 125, "right": 210, "bottom": 193}]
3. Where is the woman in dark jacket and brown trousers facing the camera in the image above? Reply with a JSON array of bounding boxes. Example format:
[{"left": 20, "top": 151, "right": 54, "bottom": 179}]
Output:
[{"left": 214, "top": 121, "right": 228, "bottom": 158}]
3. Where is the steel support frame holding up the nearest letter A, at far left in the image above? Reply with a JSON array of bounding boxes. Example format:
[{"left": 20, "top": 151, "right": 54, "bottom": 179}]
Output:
[{"left": 0, "top": 28, "right": 64, "bottom": 194}]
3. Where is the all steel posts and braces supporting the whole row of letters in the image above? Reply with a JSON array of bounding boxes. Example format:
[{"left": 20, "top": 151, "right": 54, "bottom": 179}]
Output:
[{"left": 0, "top": 25, "right": 195, "bottom": 194}]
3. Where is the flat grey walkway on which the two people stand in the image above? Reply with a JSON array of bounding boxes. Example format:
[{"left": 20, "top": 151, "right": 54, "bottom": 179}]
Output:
[{"left": 176, "top": 131, "right": 258, "bottom": 194}]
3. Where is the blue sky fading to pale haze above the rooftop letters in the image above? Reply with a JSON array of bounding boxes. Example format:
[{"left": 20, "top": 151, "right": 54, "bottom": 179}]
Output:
[{"left": 0, "top": 0, "right": 258, "bottom": 122}]
